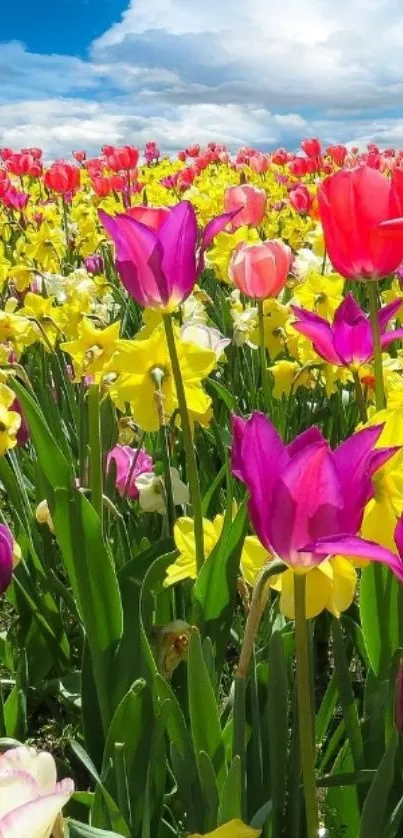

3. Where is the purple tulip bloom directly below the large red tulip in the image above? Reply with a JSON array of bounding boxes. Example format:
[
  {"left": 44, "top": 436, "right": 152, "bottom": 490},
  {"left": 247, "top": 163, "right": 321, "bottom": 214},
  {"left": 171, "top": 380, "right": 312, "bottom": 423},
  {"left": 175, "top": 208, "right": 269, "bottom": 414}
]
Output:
[{"left": 291, "top": 294, "right": 403, "bottom": 367}]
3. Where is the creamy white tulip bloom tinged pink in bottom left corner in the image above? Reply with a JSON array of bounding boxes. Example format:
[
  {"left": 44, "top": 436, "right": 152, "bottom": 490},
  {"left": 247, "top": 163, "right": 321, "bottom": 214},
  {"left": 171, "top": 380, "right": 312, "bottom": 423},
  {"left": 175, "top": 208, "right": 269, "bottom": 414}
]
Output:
[{"left": 0, "top": 747, "right": 74, "bottom": 838}]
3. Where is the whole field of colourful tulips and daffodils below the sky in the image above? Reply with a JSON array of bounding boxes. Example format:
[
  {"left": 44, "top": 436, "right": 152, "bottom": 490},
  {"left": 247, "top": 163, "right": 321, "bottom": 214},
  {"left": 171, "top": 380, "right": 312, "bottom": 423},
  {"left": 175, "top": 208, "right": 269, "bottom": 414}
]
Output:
[{"left": 0, "top": 138, "right": 403, "bottom": 838}]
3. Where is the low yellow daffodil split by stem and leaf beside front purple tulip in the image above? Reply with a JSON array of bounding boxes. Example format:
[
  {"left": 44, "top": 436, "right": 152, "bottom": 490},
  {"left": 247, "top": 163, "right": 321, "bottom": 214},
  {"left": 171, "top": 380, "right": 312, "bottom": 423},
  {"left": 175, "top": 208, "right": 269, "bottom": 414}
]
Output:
[{"left": 164, "top": 515, "right": 269, "bottom": 587}]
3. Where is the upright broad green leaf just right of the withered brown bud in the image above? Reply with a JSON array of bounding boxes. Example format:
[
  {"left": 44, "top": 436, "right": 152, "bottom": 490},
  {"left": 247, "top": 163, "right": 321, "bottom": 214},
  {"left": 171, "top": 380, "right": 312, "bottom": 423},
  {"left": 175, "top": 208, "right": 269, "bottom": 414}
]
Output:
[{"left": 188, "top": 628, "right": 226, "bottom": 791}]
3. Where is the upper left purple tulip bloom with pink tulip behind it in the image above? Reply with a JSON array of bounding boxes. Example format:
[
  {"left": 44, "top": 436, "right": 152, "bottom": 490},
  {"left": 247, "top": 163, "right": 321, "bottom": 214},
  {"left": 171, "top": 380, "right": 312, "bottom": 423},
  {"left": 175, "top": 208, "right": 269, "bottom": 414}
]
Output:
[{"left": 99, "top": 201, "right": 235, "bottom": 310}]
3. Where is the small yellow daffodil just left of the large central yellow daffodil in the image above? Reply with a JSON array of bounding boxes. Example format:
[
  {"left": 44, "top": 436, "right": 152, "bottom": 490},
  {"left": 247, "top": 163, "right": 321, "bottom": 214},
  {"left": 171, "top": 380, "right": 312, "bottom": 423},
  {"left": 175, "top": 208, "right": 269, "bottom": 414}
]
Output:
[{"left": 60, "top": 317, "right": 120, "bottom": 379}]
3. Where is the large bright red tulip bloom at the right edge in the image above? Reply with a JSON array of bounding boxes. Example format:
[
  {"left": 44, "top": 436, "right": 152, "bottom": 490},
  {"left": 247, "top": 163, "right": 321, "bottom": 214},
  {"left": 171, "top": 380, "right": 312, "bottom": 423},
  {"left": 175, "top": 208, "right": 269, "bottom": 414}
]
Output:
[{"left": 318, "top": 166, "right": 403, "bottom": 279}]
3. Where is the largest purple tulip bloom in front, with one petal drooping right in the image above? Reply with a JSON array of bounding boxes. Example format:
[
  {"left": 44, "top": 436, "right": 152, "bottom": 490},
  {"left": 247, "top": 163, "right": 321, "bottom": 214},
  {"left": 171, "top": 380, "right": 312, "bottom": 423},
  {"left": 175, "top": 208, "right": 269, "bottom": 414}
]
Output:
[{"left": 232, "top": 413, "right": 403, "bottom": 580}]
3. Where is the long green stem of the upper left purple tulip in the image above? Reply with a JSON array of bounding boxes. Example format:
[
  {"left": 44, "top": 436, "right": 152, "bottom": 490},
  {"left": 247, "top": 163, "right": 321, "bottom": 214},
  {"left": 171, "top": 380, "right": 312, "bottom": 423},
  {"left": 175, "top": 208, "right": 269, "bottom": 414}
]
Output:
[{"left": 164, "top": 314, "right": 204, "bottom": 572}]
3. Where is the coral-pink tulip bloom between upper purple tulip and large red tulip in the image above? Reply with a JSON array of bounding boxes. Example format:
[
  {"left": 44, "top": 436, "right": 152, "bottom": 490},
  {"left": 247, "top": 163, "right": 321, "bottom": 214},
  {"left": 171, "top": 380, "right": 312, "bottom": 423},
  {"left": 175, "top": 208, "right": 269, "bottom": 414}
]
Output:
[{"left": 229, "top": 240, "right": 292, "bottom": 300}]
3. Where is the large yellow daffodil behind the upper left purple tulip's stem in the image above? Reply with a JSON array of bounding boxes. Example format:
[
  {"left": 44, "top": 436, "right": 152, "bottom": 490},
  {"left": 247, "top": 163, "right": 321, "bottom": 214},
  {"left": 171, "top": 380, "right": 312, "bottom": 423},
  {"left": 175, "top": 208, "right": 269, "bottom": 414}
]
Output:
[{"left": 109, "top": 327, "right": 217, "bottom": 431}]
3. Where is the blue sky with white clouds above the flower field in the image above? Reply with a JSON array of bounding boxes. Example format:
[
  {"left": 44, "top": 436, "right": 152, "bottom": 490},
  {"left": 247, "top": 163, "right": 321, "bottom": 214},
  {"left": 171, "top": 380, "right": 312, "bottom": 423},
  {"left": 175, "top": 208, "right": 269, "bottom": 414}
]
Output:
[{"left": 0, "top": 0, "right": 403, "bottom": 157}]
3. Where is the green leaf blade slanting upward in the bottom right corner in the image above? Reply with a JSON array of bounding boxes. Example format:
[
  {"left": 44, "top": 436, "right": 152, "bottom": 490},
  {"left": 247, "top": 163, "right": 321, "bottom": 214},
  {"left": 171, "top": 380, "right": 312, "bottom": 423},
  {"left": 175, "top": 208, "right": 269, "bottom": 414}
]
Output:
[{"left": 359, "top": 732, "right": 397, "bottom": 838}]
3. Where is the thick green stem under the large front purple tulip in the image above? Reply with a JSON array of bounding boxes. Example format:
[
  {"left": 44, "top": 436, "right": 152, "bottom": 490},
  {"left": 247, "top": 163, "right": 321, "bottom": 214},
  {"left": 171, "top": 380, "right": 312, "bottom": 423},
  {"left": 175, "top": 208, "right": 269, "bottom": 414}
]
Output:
[{"left": 294, "top": 573, "right": 319, "bottom": 838}]
